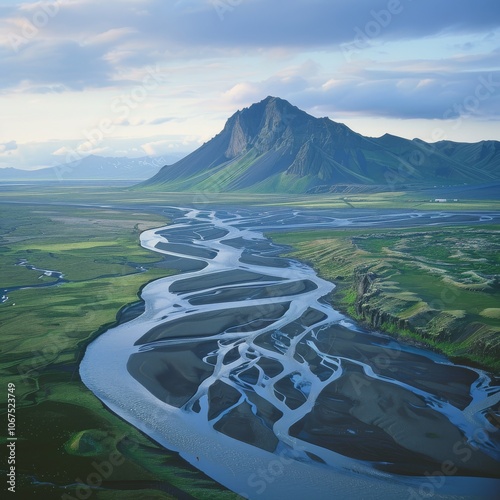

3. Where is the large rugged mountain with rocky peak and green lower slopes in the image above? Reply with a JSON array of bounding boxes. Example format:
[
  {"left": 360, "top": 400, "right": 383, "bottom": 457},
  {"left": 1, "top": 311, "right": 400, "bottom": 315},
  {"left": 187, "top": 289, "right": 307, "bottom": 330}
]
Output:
[{"left": 138, "top": 97, "right": 500, "bottom": 193}]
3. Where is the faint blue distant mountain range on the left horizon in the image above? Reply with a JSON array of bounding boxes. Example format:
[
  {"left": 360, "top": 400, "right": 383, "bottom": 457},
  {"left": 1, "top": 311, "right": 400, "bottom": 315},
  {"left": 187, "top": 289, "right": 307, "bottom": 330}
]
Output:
[{"left": 0, "top": 155, "right": 169, "bottom": 181}]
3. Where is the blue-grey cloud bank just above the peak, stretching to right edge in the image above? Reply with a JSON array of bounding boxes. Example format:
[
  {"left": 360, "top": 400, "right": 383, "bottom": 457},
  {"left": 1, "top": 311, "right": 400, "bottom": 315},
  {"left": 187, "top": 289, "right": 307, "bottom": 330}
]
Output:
[{"left": 223, "top": 51, "right": 500, "bottom": 119}]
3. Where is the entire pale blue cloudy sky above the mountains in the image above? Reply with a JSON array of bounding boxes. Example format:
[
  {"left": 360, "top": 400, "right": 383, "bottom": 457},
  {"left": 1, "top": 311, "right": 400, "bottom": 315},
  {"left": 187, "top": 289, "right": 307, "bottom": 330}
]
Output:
[{"left": 0, "top": 0, "right": 500, "bottom": 169}]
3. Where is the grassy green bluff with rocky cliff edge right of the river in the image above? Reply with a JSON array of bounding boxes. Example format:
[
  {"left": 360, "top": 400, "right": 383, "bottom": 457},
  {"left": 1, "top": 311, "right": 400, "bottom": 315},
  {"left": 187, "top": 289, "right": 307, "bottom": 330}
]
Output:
[{"left": 270, "top": 225, "right": 500, "bottom": 373}]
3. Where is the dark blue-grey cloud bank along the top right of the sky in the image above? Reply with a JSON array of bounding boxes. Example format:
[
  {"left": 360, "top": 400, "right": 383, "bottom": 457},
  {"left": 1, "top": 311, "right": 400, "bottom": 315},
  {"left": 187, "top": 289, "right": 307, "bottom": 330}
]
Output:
[{"left": 146, "top": 0, "right": 498, "bottom": 48}]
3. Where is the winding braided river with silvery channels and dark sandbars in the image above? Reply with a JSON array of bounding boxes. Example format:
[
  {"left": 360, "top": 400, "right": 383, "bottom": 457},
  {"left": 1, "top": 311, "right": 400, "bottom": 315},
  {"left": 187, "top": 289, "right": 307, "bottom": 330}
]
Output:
[{"left": 80, "top": 207, "right": 500, "bottom": 499}]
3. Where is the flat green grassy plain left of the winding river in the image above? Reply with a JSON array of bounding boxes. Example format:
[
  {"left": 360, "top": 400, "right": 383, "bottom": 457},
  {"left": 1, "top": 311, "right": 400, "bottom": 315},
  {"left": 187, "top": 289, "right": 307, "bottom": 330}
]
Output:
[{"left": 0, "top": 199, "right": 235, "bottom": 499}]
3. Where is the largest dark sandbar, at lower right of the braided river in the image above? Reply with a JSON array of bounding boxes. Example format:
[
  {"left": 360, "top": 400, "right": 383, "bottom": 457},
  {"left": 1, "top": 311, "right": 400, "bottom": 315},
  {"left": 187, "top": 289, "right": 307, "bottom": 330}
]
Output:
[{"left": 291, "top": 363, "right": 499, "bottom": 476}]
